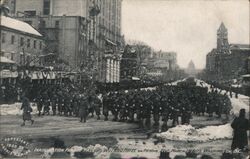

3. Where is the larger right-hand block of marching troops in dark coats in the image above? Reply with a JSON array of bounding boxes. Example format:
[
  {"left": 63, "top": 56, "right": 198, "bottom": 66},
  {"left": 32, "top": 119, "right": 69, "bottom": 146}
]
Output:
[{"left": 100, "top": 86, "right": 231, "bottom": 131}]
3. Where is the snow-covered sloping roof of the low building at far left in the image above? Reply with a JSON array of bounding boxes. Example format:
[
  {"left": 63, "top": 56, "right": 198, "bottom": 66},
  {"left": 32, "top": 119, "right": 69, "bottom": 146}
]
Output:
[{"left": 0, "top": 15, "right": 42, "bottom": 36}]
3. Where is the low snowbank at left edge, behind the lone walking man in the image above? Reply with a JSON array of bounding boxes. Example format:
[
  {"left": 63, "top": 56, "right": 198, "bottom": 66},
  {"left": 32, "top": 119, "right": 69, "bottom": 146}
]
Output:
[{"left": 0, "top": 103, "right": 37, "bottom": 115}]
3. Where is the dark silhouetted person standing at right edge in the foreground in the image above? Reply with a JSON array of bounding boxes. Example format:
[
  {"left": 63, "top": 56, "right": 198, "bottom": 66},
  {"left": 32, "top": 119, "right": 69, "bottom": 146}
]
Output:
[{"left": 231, "top": 109, "right": 250, "bottom": 150}]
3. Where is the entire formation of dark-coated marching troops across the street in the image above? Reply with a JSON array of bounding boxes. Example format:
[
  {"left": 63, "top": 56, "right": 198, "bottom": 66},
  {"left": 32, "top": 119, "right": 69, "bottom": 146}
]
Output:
[{"left": 10, "top": 78, "right": 231, "bottom": 131}]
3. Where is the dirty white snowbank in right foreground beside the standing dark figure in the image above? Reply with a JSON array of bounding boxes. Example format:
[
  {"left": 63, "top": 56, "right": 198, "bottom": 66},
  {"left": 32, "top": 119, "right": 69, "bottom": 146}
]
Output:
[{"left": 156, "top": 124, "right": 233, "bottom": 142}]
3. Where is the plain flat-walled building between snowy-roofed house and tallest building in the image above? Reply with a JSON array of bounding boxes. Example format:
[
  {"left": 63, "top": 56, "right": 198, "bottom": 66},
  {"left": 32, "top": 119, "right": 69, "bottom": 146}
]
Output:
[{"left": 14, "top": 15, "right": 87, "bottom": 69}]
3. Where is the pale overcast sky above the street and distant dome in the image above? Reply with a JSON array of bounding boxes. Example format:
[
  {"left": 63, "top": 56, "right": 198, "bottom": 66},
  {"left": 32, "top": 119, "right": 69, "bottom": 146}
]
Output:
[{"left": 122, "top": 0, "right": 250, "bottom": 68}]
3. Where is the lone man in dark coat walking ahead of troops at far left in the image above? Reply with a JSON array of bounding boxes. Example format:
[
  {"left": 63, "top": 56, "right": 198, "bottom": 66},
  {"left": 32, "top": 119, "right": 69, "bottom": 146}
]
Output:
[{"left": 21, "top": 97, "right": 34, "bottom": 126}]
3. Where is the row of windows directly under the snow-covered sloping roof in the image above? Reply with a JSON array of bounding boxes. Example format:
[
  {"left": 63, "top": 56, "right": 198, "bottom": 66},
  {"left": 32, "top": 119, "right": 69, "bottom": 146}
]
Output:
[{"left": 1, "top": 33, "right": 42, "bottom": 50}]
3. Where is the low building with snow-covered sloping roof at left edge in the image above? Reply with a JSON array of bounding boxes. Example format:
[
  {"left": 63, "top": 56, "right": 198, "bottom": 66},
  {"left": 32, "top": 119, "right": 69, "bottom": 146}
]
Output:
[{"left": 0, "top": 15, "right": 44, "bottom": 66}]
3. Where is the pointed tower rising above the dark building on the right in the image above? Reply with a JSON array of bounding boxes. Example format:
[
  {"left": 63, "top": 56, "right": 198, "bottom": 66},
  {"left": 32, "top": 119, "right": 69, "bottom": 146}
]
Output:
[{"left": 217, "top": 22, "right": 229, "bottom": 53}]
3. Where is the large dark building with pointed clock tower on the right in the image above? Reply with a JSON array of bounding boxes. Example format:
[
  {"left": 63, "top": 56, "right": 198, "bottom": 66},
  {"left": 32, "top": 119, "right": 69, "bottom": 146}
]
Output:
[{"left": 206, "top": 23, "right": 250, "bottom": 80}]
